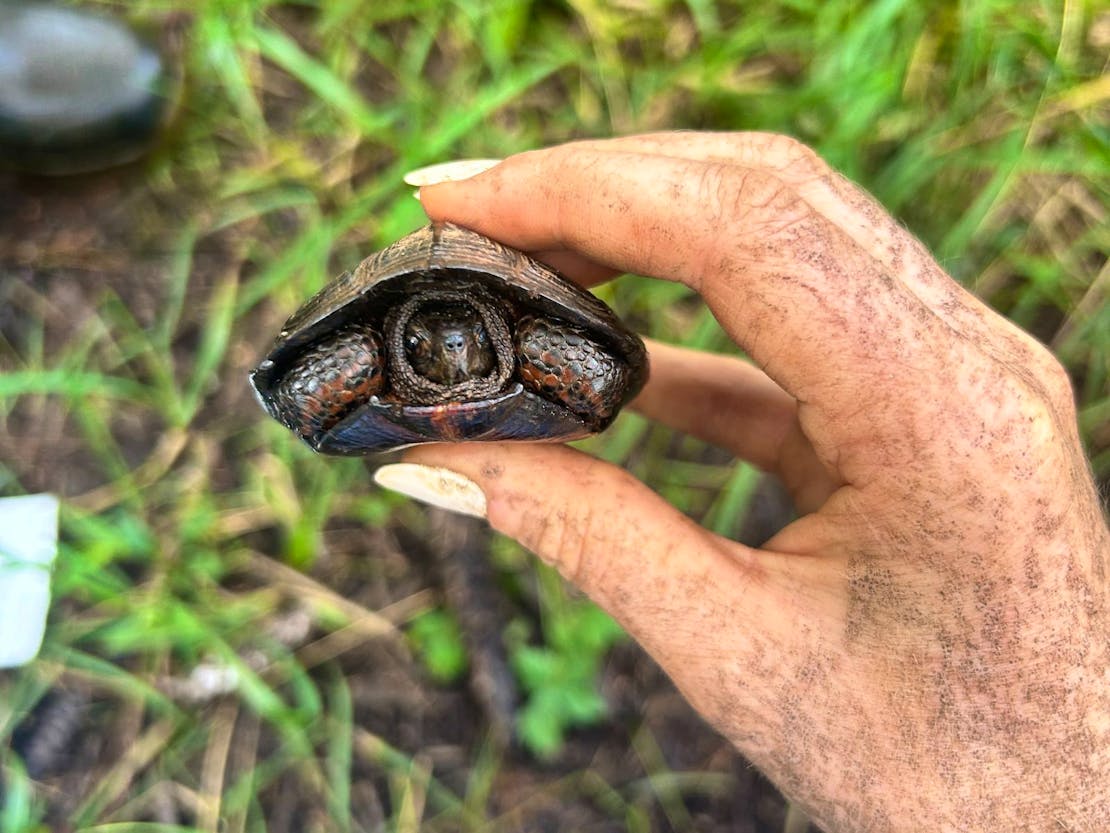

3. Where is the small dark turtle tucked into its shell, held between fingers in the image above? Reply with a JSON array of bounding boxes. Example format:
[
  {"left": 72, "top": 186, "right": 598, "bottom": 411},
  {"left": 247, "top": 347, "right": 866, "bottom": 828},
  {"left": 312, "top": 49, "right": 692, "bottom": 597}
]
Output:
[{"left": 251, "top": 223, "right": 647, "bottom": 454}]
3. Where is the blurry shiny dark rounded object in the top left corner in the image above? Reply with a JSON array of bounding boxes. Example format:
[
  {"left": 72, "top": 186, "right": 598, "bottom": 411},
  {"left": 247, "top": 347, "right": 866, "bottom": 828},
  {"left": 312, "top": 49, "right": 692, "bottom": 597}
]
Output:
[{"left": 0, "top": 0, "right": 178, "bottom": 174}]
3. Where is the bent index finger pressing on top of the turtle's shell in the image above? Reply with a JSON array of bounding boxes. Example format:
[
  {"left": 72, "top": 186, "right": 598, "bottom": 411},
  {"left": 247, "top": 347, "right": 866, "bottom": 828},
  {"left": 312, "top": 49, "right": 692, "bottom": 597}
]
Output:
[{"left": 421, "top": 143, "right": 951, "bottom": 459}]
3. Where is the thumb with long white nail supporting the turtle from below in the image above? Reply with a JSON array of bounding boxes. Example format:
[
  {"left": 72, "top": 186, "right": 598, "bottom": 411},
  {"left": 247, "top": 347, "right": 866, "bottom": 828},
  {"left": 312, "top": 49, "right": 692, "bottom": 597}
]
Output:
[{"left": 375, "top": 443, "right": 786, "bottom": 684}]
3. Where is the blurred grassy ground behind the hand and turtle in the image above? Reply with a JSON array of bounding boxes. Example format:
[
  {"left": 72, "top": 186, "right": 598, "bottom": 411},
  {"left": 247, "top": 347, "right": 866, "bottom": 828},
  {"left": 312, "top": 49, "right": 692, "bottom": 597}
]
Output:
[{"left": 0, "top": 0, "right": 1110, "bottom": 833}]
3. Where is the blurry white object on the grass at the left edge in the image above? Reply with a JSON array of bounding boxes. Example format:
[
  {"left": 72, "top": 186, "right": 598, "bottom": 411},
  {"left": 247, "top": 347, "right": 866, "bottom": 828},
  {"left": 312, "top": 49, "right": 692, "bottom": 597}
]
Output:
[{"left": 0, "top": 494, "right": 58, "bottom": 669}]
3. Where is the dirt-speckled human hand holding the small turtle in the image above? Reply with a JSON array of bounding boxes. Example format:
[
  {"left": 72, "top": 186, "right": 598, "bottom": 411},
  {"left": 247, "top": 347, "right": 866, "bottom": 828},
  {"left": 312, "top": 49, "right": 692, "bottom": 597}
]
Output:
[{"left": 375, "top": 133, "right": 1110, "bottom": 831}]
